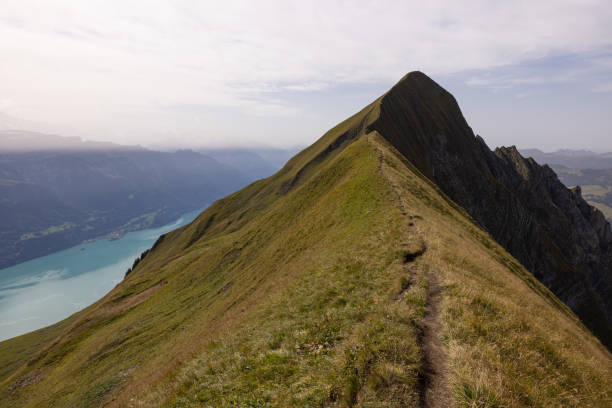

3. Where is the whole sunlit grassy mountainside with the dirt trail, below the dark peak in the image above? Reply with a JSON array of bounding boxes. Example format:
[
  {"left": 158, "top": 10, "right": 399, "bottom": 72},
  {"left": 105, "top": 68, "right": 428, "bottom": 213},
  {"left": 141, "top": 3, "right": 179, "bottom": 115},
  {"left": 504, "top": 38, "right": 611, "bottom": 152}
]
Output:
[{"left": 0, "top": 75, "right": 612, "bottom": 407}]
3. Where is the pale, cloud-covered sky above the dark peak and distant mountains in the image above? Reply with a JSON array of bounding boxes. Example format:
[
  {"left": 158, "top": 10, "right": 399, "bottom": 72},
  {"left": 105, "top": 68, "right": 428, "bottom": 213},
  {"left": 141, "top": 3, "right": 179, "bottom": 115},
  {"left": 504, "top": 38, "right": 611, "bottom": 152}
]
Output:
[{"left": 0, "top": 0, "right": 612, "bottom": 152}]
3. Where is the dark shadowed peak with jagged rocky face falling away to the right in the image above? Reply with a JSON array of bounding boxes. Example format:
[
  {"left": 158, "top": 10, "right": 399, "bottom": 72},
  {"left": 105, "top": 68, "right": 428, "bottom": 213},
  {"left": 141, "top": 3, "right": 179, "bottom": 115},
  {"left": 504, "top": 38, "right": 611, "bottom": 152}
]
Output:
[{"left": 371, "top": 72, "right": 612, "bottom": 348}]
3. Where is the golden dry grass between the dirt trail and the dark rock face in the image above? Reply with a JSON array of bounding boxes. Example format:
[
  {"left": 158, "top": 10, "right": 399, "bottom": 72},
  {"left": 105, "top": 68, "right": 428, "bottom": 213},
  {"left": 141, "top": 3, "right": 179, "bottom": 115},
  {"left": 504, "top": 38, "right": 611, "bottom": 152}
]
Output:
[{"left": 372, "top": 135, "right": 612, "bottom": 407}]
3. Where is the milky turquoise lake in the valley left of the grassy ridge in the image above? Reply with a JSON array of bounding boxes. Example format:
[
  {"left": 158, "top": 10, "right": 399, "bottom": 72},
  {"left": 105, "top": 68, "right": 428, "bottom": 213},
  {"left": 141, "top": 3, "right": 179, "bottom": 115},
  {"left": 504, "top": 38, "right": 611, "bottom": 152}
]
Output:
[{"left": 0, "top": 210, "right": 202, "bottom": 341}]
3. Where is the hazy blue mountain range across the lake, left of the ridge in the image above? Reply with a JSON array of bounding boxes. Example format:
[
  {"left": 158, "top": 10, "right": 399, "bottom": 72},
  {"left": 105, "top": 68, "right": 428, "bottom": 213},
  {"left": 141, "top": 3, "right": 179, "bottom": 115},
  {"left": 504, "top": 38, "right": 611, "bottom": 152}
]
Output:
[{"left": 0, "top": 130, "right": 296, "bottom": 268}]
